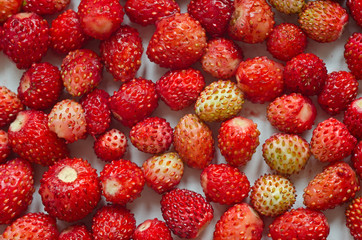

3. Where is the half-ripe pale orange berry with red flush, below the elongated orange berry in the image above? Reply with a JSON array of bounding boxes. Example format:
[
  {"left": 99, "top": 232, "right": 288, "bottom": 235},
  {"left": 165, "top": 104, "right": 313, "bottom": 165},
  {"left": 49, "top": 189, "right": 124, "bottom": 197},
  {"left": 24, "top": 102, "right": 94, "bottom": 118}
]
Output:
[{"left": 142, "top": 152, "right": 184, "bottom": 194}]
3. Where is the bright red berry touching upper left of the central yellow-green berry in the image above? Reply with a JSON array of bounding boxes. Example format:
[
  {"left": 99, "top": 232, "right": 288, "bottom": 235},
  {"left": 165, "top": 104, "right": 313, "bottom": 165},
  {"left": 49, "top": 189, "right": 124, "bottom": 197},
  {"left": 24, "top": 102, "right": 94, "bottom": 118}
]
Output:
[{"left": 156, "top": 68, "right": 205, "bottom": 111}]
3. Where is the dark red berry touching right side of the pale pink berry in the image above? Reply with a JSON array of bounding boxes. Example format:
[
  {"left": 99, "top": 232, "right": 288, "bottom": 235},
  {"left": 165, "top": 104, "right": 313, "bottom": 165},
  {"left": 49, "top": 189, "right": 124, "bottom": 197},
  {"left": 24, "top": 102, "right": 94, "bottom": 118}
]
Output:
[{"left": 79, "top": 89, "right": 111, "bottom": 136}]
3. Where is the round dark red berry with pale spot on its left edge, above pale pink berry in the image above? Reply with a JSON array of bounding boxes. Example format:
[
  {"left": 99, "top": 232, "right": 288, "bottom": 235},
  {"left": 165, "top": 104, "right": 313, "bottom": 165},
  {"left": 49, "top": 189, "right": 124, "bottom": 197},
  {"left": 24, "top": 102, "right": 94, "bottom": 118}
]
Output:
[{"left": 18, "top": 62, "right": 63, "bottom": 110}]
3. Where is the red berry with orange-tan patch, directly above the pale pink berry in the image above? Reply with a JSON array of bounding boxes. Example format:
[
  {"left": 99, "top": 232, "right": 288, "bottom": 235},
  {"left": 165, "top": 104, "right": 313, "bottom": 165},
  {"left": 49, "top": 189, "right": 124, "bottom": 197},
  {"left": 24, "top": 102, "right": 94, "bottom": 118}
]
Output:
[{"left": 61, "top": 49, "right": 103, "bottom": 96}]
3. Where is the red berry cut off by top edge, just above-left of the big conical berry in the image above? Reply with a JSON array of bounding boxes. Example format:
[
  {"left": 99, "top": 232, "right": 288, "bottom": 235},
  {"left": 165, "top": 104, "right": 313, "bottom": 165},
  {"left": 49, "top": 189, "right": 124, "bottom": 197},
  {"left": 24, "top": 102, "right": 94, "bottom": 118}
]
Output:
[{"left": 124, "top": 0, "right": 180, "bottom": 26}]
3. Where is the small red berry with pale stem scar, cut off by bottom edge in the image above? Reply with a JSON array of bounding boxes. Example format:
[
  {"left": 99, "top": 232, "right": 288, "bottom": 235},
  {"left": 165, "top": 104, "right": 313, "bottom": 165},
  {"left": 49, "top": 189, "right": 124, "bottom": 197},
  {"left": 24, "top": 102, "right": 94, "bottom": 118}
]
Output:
[{"left": 133, "top": 218, "right": 173, "bottom": 240}]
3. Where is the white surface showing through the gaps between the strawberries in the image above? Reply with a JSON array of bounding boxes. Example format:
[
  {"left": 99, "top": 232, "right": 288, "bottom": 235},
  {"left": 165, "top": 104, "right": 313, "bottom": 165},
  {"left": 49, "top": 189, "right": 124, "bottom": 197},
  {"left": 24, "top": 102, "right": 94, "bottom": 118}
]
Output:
[{"left": 0, "top": 0, "right": 362, "bottom": 240}]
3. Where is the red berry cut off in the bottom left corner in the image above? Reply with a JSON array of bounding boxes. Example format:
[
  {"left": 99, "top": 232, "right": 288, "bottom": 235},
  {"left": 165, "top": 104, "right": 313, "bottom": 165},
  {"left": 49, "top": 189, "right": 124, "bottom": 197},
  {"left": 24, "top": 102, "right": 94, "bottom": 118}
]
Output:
[{"left": 0, "top": 212, "right": 59, "bottom": 240}]
